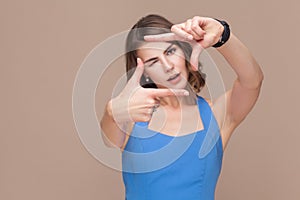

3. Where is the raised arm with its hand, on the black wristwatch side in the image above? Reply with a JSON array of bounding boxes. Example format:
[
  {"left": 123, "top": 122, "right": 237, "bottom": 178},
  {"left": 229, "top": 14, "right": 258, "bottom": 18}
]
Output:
[{"left": 145, "top": 16, "right": 263, "bottom": 148}]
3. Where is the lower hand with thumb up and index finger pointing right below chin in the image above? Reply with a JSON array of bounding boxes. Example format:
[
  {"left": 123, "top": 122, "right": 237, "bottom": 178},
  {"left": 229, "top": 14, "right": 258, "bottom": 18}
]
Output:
[{"left": 110, "top": 58, "right": 189, "bottom": 123}]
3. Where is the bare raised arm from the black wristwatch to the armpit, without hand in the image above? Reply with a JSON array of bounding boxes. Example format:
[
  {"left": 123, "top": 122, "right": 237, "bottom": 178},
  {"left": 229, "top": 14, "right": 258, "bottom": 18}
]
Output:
[{"left": 213, "top": 33, "right": 264, "bottom": 146}]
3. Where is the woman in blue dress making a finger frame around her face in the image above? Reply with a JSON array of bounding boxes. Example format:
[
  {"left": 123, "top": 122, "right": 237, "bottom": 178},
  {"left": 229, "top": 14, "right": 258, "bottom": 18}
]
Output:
[{"left": 101, "top": 15, "right": 263, "bottom": 200}]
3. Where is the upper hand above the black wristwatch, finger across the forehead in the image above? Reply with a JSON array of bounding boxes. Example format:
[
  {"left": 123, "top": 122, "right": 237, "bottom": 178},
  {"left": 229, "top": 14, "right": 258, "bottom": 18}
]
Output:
[{"left": 144, "top": 16, "right": 224, "bottom": 71}]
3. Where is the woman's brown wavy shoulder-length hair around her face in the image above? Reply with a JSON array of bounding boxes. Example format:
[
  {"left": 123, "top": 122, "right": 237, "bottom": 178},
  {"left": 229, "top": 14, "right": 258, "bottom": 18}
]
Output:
[{"left": 125, "top": 14, "right": 206, "bottom": 93}]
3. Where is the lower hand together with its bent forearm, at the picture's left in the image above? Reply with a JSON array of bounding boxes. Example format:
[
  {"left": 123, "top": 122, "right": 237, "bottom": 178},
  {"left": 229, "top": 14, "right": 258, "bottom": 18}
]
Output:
[{"left": 100, "top": 55, "right": 189, "bottom": 148}]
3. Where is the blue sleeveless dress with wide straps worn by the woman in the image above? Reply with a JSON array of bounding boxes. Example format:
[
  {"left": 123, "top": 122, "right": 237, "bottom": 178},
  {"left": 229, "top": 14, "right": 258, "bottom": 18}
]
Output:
[{"left": 122, "top": 96, "right": 223, "bottom": 200}]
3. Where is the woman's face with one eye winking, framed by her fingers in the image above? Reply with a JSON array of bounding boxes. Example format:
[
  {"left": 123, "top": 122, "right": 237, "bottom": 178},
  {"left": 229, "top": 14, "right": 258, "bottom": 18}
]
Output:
[{"left": 137, "top": 42, "right": 188, "bottom": 89}]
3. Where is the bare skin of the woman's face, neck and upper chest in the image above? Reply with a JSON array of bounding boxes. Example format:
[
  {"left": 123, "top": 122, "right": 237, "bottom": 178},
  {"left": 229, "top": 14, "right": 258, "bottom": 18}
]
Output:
[{"left": 137, "top": 42, "right": 203, "bottom": 136}]
